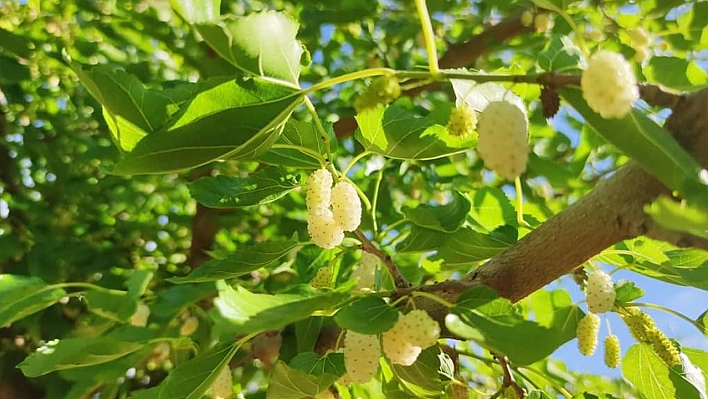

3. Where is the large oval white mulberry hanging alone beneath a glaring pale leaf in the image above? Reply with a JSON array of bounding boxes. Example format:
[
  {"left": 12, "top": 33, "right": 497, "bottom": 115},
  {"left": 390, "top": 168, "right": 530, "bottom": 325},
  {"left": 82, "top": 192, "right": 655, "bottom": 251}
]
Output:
[{"left": 477, "top": 101, "right": 529, "bottom": 180}]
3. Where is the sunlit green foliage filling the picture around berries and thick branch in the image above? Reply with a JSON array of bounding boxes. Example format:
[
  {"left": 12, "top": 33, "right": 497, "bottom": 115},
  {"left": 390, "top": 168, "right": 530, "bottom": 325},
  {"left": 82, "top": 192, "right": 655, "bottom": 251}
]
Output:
[{"left": 0, "top": 0, "right": 708, "bottom": 399}]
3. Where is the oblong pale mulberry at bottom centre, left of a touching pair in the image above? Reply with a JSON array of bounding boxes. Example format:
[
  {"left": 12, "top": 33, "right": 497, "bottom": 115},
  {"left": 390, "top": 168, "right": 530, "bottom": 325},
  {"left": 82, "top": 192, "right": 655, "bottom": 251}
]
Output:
[{"left": 344, "top": 330, "right": 381, "bottom": 384}]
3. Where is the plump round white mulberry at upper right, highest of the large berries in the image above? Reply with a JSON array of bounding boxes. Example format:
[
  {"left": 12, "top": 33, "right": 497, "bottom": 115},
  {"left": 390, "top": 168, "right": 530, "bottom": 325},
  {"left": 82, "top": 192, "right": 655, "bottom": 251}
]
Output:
[{"left": 580, "top": 51, "right": 639, "bottom": 119}]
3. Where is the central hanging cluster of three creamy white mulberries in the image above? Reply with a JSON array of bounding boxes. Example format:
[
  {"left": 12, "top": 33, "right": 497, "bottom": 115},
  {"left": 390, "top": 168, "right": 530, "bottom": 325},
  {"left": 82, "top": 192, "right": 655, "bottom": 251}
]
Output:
[{"left": 306, "top": 169, "right": 361, "bottom": 249}]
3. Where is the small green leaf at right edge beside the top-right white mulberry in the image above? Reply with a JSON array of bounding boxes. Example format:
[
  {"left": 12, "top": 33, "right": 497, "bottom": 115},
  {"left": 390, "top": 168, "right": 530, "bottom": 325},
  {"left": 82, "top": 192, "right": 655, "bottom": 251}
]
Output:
[{"left": 644, "top": 56, "right": 708, "bottom": 92}]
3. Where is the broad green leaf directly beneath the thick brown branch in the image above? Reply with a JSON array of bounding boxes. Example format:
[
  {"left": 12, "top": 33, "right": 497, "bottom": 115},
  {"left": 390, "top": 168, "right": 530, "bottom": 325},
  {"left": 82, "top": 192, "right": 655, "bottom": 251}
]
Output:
[{"left": 445, "top": 287, "right": 583, "bottom": 365}]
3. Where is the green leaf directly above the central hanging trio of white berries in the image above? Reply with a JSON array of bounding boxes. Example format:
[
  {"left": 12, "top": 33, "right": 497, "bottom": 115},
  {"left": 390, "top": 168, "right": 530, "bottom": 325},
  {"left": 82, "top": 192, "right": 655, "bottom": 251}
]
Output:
[{"left": 260, "top": 119, "right": 337, "bottom": 169}]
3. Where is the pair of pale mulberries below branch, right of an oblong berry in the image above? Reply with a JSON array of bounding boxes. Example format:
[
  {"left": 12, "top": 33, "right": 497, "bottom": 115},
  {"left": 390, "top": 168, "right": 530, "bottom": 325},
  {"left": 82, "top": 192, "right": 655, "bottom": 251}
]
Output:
[{"left": 381, "top": 310, "right": 440, "bottom": 366}]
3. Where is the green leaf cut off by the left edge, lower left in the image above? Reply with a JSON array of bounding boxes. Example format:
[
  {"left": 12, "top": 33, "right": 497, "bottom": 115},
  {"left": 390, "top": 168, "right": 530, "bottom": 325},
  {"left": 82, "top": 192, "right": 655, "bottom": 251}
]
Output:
[{"left": 0, "top": 274, "right": 66, "bottom": 327}]
